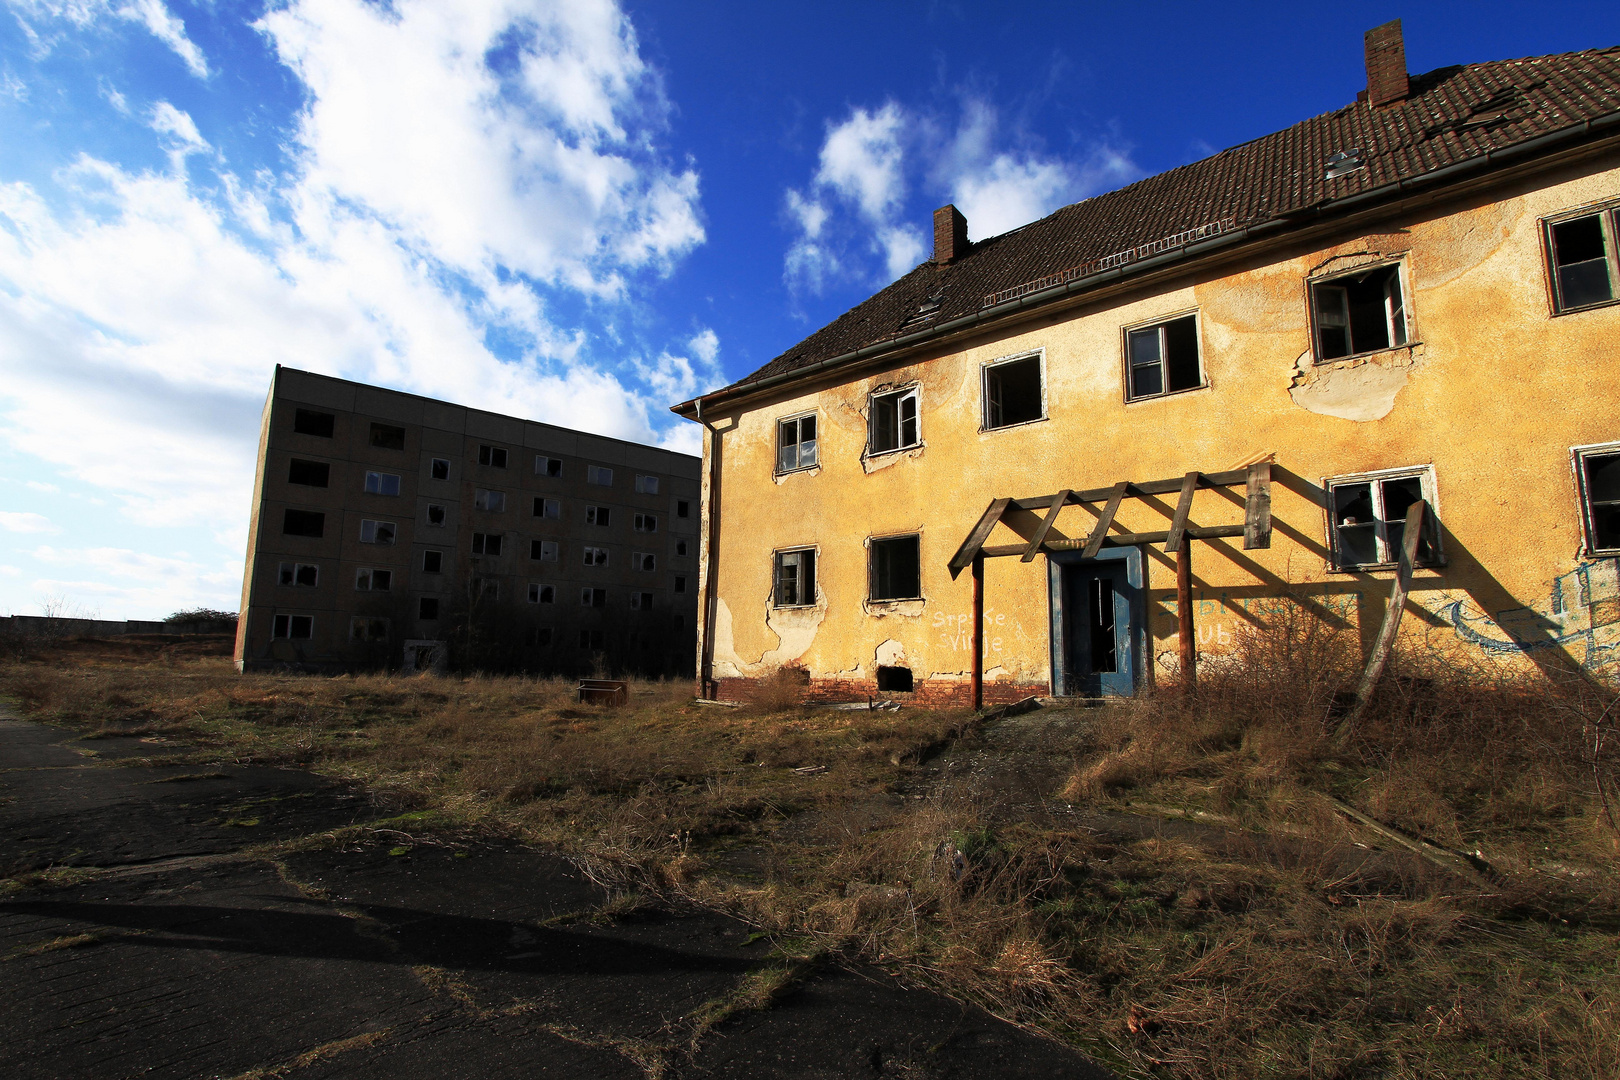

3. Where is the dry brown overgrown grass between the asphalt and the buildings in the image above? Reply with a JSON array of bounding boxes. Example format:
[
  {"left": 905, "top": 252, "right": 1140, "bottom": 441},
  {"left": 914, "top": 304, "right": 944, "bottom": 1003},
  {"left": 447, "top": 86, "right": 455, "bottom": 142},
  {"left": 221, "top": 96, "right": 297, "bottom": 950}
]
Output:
[{"left": 0, "top": 634, "right": 1620, "bottom": 1080}]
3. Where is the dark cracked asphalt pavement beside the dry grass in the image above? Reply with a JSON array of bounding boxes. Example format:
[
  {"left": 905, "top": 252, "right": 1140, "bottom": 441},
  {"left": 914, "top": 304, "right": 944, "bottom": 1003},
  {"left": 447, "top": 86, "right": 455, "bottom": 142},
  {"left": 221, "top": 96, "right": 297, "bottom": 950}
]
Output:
[{"left": 0, "top": 714, "right": 1106, "bottom": 1080}]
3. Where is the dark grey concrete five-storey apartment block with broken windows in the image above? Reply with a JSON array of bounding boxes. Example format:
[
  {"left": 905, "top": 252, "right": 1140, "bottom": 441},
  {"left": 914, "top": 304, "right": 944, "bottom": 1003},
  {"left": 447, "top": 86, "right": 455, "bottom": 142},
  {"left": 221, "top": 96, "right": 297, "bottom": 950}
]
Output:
[{"left": 237, "top": 366, "right": 701, "bottom": 675}]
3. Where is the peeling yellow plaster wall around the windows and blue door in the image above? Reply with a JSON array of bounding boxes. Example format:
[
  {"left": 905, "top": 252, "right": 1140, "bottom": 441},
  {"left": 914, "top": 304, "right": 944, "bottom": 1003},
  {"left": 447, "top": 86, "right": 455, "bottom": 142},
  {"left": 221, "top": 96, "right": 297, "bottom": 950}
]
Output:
[{"left": 705, "top": 167, "right": 1620, "bottom": 683}]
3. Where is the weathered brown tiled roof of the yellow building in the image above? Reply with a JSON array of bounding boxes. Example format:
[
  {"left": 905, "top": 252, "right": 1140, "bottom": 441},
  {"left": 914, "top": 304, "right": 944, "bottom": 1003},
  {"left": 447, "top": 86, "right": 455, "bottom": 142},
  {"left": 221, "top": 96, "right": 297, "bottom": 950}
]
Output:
[{"left": 706, "top": 47, "right": 1620, "bottom": 410}]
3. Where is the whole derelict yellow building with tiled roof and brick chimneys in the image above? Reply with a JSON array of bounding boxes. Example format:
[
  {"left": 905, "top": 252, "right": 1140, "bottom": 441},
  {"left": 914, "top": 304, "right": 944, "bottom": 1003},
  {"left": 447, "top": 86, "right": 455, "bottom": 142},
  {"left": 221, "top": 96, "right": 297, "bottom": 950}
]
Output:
[{"left": 676, "top": 21, "right": 1620, "bottom": 703}]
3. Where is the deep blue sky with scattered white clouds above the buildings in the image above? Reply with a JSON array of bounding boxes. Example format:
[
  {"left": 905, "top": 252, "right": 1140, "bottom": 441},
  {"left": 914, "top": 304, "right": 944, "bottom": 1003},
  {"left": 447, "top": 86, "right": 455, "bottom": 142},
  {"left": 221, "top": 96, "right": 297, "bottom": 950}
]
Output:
[{"left": 0, "top": 0, "right": 1620, "bottom": 619}]
